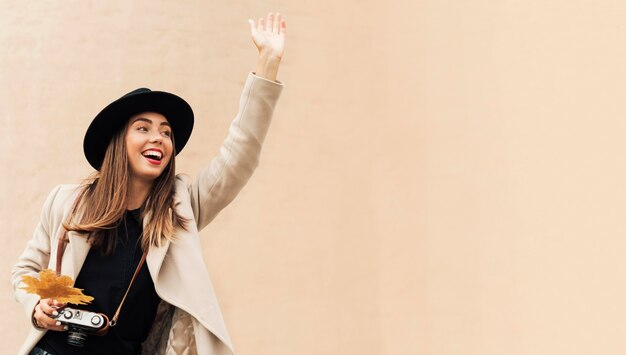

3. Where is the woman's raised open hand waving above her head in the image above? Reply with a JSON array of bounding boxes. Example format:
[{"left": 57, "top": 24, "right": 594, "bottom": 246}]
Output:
[{"left": 248, "top": 12, "right": 287, "bottom": 59}]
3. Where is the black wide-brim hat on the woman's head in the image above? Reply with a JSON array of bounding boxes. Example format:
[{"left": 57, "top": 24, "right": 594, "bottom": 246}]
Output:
[{"left": 83, "top": 88, "right": 193, "bottom": 170}]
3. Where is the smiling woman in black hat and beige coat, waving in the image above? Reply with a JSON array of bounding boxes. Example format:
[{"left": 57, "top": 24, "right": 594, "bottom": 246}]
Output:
[{"left": 12, "top": 13, "right": 286, "bottom": 355}]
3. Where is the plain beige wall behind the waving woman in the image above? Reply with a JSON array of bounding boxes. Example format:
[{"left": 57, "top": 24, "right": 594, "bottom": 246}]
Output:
[{"left": 0, "top": 0, "right": 626, "bottom": 355}]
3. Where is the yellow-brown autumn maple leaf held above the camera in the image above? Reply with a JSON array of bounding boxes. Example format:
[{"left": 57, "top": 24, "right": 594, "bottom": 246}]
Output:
[{"left": 21, "top": 269, "right": 93, "bottom": 305}]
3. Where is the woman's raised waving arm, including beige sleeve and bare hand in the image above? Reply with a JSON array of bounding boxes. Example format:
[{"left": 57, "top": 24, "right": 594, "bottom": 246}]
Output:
[{"left": 182, "top": 13, "right": 286, "bottom": 230}]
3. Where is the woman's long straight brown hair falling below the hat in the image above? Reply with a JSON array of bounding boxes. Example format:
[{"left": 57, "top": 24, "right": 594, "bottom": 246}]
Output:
[{"left": 63, "top": 121, "right": 189, "bottom": 255}]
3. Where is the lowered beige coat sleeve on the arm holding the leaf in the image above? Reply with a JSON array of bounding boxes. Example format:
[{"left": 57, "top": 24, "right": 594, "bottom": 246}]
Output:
[{"left": 11, "top": 185, "right": 61, "bottom": 320}]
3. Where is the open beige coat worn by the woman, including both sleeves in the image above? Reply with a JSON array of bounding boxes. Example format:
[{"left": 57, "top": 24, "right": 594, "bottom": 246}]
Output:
[{"left": 11, "top": 73, "right": 283, "bottom": 355}]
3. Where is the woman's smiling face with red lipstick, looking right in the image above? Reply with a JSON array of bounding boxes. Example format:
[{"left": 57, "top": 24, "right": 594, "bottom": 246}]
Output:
[{"left": 125, "top": 112, "right": 174, "bottom": 182}]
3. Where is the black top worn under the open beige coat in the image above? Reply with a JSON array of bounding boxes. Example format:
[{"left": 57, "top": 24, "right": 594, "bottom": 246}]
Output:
[{"left": 37, "top": 209, "right": 160, "bottom": 355}]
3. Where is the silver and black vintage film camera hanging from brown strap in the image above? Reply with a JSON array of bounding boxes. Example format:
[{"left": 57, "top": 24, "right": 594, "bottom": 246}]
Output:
[{"left": 52, "top": 307, "right": 106, "bottom": 347}]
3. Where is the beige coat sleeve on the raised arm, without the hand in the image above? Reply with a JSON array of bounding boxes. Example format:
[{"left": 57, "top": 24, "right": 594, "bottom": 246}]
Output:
[{"left": 182, "top": 72, "right": 283, "bottom": 230}]
